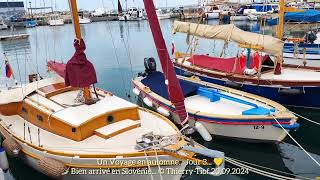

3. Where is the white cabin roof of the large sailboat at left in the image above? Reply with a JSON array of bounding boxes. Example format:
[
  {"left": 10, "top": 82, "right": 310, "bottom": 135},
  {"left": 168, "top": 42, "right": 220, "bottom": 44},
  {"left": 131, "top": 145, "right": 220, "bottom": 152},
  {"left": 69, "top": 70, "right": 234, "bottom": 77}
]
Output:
[{"left": 26, "top": 90, "right": 137, "bottom": 127}]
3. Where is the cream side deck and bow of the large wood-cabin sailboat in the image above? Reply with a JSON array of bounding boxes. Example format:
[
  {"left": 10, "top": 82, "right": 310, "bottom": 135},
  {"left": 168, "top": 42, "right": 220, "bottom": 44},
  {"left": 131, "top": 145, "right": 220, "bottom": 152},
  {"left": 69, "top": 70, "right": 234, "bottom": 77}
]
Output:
[{"left": 0, "top": 110, "right": 176, "bottom": 154}]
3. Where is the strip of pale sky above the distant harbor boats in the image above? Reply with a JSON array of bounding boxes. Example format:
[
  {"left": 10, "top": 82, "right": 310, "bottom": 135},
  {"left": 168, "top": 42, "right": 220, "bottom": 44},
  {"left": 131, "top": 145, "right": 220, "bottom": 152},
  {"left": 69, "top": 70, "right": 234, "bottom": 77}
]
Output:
[{"left": 6, "top": 0, "right": 199, "bottom": 10}]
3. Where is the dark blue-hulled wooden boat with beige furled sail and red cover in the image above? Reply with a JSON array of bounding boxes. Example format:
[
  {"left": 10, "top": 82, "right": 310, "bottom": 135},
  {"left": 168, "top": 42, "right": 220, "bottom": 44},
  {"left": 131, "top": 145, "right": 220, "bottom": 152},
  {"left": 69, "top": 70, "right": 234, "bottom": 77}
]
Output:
[{"left": 173, "top": 22, "right": 320, "bottom": 109}]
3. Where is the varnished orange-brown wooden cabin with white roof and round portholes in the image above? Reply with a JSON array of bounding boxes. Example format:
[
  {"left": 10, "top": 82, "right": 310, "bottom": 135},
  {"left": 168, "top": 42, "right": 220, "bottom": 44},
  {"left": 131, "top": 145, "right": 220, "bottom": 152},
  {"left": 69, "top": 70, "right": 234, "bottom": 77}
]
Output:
[{"left": 0, "top": 79, "right": 140, "bottom": 141}]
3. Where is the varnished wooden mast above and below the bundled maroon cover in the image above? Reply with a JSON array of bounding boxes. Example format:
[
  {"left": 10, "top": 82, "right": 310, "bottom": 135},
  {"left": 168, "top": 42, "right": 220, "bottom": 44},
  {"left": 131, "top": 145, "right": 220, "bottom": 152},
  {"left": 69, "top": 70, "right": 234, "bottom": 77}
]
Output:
[{"left": 69, "top": 0, "right": 92, "bottom": 103}]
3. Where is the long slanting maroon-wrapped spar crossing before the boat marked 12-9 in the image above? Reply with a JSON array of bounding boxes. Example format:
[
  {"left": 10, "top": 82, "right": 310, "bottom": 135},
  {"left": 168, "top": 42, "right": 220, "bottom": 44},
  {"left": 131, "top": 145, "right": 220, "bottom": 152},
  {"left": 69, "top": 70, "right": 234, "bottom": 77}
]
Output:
[{"left": 143, "top": 0, "right": 188, "bottom": 125}]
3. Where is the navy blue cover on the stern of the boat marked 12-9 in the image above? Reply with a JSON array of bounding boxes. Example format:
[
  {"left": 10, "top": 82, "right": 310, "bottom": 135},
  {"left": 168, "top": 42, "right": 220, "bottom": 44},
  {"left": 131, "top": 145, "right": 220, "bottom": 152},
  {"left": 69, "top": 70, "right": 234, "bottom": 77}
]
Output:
[{"left": 141, "top": 71, "right": 198, "bottom": 100}]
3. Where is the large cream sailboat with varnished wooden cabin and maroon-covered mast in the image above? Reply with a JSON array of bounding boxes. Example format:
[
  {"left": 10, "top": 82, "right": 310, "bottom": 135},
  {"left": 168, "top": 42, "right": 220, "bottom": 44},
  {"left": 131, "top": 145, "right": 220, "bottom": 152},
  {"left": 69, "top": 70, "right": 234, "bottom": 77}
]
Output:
[{"left": 0, "top": 0, "right": 224, "bottom": 180}]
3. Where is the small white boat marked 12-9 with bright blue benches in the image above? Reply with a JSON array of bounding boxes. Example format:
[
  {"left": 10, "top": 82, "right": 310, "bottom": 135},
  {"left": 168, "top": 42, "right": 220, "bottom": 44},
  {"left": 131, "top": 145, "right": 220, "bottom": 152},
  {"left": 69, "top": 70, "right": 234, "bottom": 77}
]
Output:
[{"left": 133, "top": 68, "right": 299, "bottom": 142}]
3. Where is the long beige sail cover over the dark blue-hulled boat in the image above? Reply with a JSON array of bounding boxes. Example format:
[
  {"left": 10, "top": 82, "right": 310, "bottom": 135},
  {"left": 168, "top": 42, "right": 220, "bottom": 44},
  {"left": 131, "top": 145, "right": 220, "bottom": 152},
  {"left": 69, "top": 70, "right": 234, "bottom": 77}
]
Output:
[{"left": 172, "top": 21, "right": 284, "bottom": 57}]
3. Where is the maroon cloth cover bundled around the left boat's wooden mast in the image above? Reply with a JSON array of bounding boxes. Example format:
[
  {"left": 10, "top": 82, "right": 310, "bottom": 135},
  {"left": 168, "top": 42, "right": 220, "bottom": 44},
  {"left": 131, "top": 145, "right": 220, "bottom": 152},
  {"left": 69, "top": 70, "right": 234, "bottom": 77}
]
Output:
[{"left": 65, "top": 39, "right": 97, "bottom": 88}]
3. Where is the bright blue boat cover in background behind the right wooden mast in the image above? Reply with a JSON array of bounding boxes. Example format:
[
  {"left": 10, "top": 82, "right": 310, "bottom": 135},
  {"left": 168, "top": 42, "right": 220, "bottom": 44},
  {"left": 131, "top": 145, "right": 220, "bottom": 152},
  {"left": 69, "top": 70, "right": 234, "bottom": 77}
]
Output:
[{"left": 266, "top": 9, "right": 320, "bottom": 26}]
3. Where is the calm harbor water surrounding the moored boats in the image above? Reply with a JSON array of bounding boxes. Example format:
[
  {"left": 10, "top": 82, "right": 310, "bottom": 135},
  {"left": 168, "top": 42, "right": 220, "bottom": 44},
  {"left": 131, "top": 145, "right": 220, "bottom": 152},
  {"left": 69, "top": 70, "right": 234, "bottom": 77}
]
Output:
[{"left": 0, "top": 20, "right": 320, "bottom": 180}]
